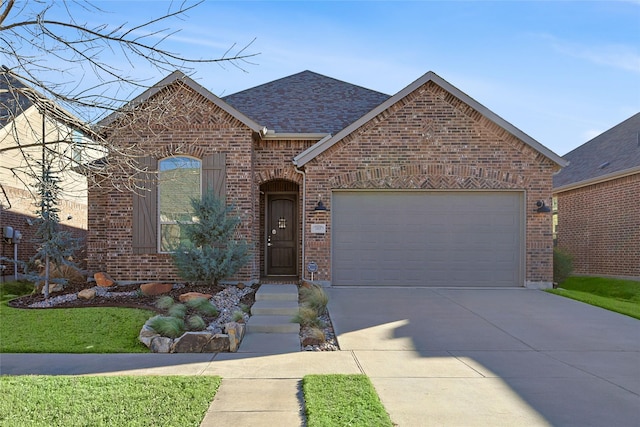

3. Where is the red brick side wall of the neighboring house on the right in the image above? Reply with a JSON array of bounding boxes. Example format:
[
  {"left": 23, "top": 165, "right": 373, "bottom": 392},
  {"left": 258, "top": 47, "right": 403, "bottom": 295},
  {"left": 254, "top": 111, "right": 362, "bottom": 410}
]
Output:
[{"left": 556, "top": 173, "right": 640, "bottom": 277}]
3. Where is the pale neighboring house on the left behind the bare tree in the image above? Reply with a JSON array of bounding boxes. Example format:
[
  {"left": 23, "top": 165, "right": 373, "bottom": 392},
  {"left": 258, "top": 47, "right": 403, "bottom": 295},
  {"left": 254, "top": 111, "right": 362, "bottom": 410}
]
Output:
[{"left": 0, "top": 72, "right": 95, "bottom": 275}]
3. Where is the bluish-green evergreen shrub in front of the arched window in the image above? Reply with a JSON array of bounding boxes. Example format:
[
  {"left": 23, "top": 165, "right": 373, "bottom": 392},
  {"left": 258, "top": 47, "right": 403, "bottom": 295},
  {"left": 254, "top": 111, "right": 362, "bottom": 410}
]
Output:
[{"left": 172, "top": 193, "right": 249, "bottom": 285}]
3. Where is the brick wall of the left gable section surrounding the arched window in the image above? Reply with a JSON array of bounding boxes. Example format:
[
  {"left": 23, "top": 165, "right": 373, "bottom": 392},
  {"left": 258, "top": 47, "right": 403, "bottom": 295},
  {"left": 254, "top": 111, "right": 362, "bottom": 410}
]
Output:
[{"left": 88, "top": 84, "right": 258, "bottom": 281}]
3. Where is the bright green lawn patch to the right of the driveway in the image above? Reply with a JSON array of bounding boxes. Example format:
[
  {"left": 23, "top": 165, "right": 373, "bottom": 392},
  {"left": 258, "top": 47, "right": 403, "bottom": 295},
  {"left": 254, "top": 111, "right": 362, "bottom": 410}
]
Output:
[{"left": 547, "top": 276, "right": 640, "bottom": 319}]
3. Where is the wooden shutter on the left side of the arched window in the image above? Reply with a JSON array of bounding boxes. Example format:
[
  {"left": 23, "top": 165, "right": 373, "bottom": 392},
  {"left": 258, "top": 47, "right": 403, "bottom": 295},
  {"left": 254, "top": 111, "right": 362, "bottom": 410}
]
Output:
[{"left": 132, "top": 157, "right": 158, "bottom": 254}]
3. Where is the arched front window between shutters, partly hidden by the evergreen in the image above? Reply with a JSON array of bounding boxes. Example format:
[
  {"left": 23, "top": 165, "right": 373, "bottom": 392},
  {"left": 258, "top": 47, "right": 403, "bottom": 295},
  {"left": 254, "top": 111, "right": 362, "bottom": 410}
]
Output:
[{"left": 158, "top": 157, "right": 201, "bottom": 252}]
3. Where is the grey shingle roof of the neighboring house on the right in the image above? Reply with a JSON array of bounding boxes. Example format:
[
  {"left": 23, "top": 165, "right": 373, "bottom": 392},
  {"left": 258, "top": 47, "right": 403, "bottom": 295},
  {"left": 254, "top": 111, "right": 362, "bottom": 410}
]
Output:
[{"left": 553, "top": 113, "right": 640, "bottom": 190}]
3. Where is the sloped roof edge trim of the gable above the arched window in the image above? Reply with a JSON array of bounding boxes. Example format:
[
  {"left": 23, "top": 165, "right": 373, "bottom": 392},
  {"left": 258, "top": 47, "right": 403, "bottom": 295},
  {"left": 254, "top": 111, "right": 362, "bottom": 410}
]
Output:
[{"left": 98, "top": 71, "right": 265, "bottom": 132}]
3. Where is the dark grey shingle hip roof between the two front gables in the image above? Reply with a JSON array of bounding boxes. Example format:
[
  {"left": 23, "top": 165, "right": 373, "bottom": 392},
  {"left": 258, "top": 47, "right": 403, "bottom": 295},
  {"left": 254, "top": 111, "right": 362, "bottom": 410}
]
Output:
[{"left": 222, "top": 71, "right": 389, "bottom": 134}]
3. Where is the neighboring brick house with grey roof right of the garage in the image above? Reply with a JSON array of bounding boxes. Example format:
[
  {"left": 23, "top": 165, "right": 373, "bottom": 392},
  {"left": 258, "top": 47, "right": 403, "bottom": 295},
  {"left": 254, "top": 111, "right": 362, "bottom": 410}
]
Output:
[{"left": 553, "top": 113, "right": 640, "bottom": 279}]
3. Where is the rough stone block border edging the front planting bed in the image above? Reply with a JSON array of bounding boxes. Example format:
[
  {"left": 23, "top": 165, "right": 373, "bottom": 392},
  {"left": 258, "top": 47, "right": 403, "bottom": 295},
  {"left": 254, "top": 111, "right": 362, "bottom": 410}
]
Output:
[{"left": 138, "top": 317, "right": 246, "bottom": 353}]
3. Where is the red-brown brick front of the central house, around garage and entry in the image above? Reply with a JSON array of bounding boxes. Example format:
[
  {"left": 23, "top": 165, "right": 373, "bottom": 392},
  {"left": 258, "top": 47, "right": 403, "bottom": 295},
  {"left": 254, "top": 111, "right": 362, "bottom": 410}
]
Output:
[{"left": 89, "top": 79, "right": 557, "bottom": 283}]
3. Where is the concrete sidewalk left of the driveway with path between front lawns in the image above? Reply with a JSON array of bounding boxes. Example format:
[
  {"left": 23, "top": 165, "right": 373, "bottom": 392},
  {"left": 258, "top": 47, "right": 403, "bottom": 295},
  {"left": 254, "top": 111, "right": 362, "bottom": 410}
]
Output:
[{"left": 0, "top": 351, "right": 362, "bottom": 427}]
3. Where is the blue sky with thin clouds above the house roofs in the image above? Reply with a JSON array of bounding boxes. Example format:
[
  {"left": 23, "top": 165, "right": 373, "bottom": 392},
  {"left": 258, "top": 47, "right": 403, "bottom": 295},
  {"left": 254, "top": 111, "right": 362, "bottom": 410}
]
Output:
[{"left": 79, "top": 0, "right": 640, "bottom": 155}]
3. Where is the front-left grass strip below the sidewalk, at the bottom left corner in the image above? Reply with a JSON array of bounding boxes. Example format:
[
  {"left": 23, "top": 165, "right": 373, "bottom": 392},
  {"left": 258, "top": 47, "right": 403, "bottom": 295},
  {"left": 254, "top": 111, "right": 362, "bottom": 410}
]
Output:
[{"left": 0, "top": 376, "right": 220, "bottom": 427}]
